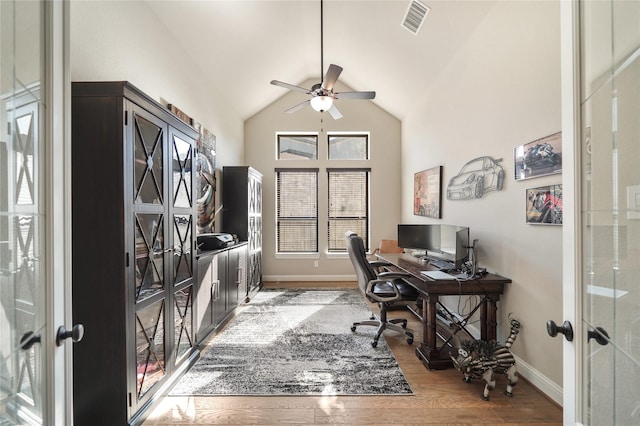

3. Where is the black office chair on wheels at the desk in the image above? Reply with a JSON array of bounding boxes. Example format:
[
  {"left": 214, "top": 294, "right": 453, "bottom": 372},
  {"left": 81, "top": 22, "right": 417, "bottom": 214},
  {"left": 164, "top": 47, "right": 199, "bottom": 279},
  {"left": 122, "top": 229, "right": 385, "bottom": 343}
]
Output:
[{"left": 345, "top": 231, "right": 419, "bottom": 348}]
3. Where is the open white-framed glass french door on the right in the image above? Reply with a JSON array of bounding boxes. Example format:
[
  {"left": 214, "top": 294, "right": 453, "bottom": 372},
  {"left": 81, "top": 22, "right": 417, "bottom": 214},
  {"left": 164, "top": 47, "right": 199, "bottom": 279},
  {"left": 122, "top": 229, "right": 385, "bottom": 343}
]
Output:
[{"left": 562, "top": 0, "right": 640, "bottom": 425}]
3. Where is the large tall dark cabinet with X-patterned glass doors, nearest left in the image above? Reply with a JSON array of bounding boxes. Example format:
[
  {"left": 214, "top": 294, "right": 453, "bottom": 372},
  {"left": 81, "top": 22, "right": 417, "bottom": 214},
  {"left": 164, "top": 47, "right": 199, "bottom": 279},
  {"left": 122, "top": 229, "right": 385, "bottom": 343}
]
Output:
[{"left": 71, "top": 82, "right": 198, "bottom": 425}]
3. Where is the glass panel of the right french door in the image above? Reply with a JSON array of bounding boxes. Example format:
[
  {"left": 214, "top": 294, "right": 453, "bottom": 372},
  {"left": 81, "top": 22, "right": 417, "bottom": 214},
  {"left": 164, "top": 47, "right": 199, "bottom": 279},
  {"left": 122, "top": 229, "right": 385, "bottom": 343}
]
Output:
[{"left": 580, "top": 1, "right": 640, "bottom": 425}]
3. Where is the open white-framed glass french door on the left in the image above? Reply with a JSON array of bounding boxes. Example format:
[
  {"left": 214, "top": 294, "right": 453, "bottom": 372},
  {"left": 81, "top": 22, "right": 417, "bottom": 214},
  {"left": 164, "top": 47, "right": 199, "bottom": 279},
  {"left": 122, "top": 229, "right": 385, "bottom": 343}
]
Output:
[{"left": 0, "top": 0, "right": 71, "bottom": 425}]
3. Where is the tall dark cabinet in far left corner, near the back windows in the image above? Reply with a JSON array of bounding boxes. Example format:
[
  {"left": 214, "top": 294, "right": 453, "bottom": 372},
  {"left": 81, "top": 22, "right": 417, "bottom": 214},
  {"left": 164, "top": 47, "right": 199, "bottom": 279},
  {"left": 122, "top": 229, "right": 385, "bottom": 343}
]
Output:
[{"left": 222, "top": 166, "right": 262, "bottom": 298}]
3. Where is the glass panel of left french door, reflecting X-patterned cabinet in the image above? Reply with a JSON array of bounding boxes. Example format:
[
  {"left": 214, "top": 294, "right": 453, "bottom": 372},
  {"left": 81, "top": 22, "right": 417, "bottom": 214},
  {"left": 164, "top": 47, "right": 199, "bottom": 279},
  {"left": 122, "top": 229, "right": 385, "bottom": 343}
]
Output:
[{"left": 0, "top": 0, "right": 45, "bottom": 425}]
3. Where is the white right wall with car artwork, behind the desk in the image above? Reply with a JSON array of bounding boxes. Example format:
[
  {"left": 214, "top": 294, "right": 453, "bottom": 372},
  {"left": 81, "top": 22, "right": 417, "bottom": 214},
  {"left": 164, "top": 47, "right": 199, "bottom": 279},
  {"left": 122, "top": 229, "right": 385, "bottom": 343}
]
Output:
[{"left": 402, "top": 1, "right": 562, "bottom": 401}]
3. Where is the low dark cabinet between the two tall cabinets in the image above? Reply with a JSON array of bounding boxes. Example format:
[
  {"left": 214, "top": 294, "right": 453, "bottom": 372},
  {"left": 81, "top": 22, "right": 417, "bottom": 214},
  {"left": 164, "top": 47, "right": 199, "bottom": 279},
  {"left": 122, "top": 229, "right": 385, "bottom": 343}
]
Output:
[{"left": 195, "top": 243, "right": 247, "bottom": 343}]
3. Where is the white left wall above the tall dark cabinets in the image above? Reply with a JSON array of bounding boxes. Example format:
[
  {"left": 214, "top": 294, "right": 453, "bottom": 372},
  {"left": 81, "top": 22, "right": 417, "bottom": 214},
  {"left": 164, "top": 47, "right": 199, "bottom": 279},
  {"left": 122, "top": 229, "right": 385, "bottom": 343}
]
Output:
[{"left": 70, "top": 1, "right": 244, "bottom": 168}]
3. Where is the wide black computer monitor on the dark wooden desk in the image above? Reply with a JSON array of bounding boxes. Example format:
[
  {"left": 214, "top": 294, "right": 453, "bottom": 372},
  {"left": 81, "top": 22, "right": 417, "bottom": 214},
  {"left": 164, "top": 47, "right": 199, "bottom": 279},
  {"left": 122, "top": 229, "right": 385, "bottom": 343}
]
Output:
[{"left": 398, "top": 224, "right": 469, "bottom": 268}]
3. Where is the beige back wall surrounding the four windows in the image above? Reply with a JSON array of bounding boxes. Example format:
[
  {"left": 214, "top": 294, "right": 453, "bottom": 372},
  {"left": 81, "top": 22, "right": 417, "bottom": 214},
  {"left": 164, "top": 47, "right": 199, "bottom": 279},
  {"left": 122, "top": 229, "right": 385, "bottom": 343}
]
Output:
[{"left": 245, "top": 80, "right": 401, "bottom": 281}]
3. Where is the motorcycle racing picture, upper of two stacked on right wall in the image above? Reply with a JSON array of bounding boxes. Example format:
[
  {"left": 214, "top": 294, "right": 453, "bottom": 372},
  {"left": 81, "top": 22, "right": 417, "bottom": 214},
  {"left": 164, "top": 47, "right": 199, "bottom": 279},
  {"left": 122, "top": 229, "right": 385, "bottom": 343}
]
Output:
[{"left": 513, "top": 132, "right": 562, "bottom": 180}]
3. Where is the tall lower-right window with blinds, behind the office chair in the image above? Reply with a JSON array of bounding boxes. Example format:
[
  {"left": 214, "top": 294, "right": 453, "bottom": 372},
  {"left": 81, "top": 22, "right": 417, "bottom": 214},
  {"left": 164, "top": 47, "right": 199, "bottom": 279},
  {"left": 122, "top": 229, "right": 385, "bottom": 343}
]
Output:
[{"left": 327, "top": 169, "right": 371, "bottom": 252}]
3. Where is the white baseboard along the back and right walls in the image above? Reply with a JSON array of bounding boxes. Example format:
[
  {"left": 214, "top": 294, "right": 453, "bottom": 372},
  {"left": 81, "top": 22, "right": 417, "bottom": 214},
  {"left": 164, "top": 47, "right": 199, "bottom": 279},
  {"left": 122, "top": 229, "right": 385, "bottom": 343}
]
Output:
[{"left": 262, "top": 275, "right": 562, "bottom": 406}]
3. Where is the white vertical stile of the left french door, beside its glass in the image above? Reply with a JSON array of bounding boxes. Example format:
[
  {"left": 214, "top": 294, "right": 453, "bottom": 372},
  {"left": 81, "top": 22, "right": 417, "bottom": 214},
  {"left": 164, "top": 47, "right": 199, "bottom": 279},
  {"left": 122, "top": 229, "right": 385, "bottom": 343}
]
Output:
[{"left": 43, "top": 0, "right": 73, "bottom": 425}]
